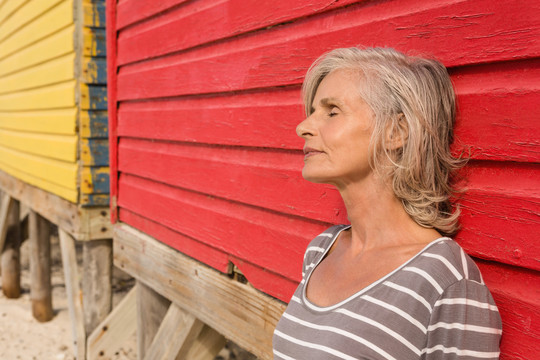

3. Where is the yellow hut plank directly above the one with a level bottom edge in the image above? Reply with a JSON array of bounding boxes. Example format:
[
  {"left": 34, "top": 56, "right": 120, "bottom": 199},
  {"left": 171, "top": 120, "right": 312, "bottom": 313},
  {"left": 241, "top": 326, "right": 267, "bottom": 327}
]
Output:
[{"left": 0, "top": 53, "right": 75, "bottom": 94}]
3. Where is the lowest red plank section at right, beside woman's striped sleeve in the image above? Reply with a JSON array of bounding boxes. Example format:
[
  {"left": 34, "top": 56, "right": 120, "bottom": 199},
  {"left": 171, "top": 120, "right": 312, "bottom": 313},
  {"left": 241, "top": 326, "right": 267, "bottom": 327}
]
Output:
[{"left": 477, "top": 260, "right": 540, "bottom": 360}]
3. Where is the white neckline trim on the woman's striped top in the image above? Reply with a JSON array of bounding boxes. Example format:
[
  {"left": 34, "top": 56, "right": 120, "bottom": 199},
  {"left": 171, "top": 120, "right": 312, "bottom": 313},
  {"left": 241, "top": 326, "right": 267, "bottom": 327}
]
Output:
[{"left": 302, "top": 225, "right": 452, "bottom": 312}]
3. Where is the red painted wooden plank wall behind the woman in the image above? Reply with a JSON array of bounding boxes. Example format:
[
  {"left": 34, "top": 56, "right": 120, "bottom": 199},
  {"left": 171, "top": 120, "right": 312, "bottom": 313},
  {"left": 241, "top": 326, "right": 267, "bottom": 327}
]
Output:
[{"left": 107, "top": 0, "right": 540, "bottom": 359}]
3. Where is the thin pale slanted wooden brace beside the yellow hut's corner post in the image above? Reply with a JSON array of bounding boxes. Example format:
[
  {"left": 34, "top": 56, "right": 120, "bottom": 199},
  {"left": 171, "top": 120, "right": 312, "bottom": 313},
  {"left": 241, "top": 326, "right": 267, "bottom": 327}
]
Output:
[{"left": 58, "top": 228, "right": 86, "bottom": 359}]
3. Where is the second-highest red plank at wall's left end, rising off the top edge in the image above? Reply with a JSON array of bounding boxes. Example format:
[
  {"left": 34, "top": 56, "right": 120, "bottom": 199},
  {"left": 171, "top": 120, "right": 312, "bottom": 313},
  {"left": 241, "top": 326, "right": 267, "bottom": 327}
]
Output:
[{"left": 118, "top": 0, "right": 362, "bottom": 65}]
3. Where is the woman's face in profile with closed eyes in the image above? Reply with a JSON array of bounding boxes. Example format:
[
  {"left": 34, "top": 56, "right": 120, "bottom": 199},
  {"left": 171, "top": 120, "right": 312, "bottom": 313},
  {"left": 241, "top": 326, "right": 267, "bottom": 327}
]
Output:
[{"left": 296, "top": 70, "right": 374, "bottom": 189}]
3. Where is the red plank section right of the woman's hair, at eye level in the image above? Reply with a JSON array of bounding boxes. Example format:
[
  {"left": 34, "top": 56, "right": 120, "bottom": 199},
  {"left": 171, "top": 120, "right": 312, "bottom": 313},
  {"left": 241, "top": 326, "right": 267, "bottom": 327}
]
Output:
[{"left": 452, "top": 59, "right": 540, "bottom": 162}]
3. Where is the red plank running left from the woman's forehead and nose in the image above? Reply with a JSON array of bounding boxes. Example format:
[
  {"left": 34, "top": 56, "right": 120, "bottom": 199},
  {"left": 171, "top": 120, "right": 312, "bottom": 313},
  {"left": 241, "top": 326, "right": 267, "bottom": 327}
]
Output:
[{"left": 118, "top": 88, "right": 303, "bottom": 149}]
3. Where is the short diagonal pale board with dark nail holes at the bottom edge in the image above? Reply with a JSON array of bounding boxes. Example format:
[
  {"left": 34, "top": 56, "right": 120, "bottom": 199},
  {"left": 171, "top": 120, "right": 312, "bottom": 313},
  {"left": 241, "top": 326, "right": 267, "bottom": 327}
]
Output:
[{"left": 86, "top": 287, "right": 137, "bottom": 360}]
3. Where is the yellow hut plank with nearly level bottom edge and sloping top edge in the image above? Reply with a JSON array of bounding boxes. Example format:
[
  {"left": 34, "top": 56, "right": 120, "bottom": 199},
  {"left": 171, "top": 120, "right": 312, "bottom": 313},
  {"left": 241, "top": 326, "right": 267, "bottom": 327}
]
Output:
[{"left": 0, "top": 80, "right": 75, "bottom": 111}]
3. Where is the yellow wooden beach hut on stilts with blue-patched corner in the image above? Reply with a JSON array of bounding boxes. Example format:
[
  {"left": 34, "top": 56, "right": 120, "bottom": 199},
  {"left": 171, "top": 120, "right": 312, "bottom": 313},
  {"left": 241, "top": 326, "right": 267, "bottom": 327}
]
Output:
[{"left": 0, "top": 0, "right": 112, "bottom": 358}]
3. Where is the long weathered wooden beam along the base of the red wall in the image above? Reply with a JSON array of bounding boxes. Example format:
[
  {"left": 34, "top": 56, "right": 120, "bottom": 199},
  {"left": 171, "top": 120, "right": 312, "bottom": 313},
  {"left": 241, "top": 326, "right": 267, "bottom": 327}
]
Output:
[{"left": 114, "top": 224, "right": 285, "bottom": 359}]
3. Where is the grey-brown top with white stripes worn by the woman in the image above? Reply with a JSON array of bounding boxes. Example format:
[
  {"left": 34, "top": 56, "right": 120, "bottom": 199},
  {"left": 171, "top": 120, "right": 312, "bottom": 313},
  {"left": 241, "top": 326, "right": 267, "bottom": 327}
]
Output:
[{"left": 273, "top": 225, "right": 502, "bottom": 360}]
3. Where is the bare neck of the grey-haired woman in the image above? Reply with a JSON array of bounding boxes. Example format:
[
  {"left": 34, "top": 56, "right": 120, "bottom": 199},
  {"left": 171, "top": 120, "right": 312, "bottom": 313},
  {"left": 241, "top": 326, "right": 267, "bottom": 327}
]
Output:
[{"left": 338, "top": 176, "right": 440, "bottom": 253}]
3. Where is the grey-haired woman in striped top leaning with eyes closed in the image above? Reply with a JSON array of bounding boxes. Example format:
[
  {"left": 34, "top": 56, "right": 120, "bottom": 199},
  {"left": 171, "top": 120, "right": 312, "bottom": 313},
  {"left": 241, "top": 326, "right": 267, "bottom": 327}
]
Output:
[{"left": 273, "top": 48, "right": 501, "bottom": 360}]
